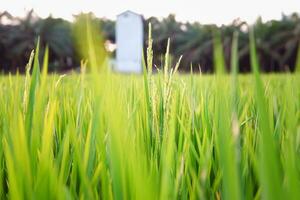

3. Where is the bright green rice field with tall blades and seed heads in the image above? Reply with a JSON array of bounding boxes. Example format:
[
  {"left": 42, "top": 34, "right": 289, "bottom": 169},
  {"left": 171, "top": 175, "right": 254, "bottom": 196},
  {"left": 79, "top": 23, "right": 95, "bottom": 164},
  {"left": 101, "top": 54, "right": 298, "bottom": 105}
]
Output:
[{"left": 0, "top": 23, "right": 300, "bottom": 200}]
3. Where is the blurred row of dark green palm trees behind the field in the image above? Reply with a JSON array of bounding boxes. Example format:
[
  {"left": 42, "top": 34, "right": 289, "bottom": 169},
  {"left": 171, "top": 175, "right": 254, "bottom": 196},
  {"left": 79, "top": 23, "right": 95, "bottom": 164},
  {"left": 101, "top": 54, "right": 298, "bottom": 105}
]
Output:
[{"left": 0, "top": 11, "right": 300, "bottom": 73}]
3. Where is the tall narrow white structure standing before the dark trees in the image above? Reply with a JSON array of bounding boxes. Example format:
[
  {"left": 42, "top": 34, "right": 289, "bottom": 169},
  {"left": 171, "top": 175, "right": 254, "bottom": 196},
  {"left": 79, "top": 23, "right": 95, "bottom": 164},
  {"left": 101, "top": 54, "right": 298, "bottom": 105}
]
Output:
[{"left": 116, "top": 11, "right": 144, "bottom": 73}]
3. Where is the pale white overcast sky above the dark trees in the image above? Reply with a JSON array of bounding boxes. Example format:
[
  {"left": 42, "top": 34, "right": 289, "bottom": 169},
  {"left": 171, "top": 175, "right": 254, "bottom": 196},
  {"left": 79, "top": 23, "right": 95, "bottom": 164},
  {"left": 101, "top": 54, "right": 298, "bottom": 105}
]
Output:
[{"left": 0, "top": 0, "right": 300, "bottom": 25}]
